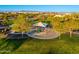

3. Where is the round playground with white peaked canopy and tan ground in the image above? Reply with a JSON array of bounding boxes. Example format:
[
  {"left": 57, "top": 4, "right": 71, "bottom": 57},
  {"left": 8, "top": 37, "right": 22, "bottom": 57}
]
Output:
[{"left": 27, "top": 22, "right": 59, "bottom": 39}]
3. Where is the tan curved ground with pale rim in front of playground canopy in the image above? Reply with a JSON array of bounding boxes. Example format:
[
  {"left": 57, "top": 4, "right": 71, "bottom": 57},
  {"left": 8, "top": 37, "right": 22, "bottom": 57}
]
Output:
[{"left": 27, "top": 31, "right": 59, "bottom": 39}]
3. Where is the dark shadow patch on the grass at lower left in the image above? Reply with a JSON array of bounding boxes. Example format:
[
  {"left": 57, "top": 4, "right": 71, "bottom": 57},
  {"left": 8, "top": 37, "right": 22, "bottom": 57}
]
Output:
[{"left": 0, "top": 38, "right": 28, "bottom": 53}]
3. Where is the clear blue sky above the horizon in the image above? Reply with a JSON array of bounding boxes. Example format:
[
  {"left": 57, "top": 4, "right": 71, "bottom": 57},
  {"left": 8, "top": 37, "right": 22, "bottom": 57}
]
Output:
[{"left": 0, "top": 5, "right": 79, "bottom": 12}]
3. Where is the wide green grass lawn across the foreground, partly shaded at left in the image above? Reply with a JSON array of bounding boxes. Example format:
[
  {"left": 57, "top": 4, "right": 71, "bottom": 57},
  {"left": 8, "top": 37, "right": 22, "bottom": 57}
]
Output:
[{"left": 0, "top": 34, "right": 79, "bottom": 54}]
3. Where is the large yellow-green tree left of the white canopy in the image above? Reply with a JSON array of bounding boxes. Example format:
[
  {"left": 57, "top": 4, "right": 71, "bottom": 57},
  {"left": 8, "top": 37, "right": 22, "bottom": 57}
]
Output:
[{"left": 12, "top": 14, "right": 29, "bottom": 32}]
